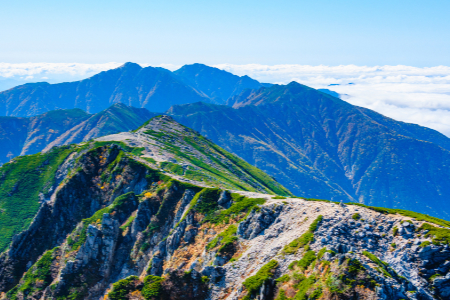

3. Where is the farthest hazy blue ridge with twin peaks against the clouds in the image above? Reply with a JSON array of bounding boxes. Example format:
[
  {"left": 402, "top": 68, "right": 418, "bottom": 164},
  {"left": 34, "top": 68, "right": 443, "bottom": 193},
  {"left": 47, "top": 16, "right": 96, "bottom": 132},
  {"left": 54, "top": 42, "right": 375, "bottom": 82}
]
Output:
[{"left": 0, "top": 63, "right": 267, "bottom": 117}]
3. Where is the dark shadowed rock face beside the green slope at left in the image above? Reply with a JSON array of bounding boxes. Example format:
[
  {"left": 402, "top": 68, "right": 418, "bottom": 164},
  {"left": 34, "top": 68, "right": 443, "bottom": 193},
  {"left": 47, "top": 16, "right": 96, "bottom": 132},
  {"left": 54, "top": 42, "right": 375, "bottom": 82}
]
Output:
[{"left": 0, "top": 146, "right": 146, "bottom": 290}]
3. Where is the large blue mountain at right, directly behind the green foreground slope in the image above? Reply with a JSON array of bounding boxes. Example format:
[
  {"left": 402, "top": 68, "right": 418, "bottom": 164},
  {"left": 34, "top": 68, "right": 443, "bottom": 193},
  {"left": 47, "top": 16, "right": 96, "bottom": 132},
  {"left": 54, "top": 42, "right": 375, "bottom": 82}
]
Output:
[{"left": 168, "top": 83, "right": 450, "bottom": 217}]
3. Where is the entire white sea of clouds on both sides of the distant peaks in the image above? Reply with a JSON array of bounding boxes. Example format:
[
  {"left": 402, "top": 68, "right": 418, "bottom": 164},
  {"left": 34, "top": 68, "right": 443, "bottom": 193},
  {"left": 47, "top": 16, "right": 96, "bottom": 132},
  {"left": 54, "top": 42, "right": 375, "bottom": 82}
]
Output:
[{"left": 0, "top": 63, "right": 450, "bottom": 137}]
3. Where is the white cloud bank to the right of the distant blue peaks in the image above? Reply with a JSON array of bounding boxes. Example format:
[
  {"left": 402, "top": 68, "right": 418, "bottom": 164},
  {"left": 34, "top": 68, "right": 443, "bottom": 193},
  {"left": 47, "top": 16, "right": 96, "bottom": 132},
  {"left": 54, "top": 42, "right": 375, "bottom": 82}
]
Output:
[{"left": 215, "top": 64, "right": 450, "bottom": 137}]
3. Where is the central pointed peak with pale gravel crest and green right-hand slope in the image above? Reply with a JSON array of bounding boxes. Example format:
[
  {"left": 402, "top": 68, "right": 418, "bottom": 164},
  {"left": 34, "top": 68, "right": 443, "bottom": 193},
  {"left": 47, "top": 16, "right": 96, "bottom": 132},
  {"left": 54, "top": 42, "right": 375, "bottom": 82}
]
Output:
[{"left": 98, "top": 116, "right": 292, "bottom": 196}]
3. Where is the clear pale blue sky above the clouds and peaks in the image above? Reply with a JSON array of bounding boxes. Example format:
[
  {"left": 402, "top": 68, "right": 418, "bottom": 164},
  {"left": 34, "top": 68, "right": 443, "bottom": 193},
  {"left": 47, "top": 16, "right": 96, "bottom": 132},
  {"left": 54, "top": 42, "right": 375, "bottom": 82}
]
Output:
[{"left": 0, "top": 0, "right": 450, "bottom": 67}]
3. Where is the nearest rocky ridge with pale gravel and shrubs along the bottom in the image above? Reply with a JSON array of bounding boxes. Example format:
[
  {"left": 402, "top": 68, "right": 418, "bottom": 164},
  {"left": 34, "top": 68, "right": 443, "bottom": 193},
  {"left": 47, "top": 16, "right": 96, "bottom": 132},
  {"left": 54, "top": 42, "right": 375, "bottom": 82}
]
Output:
[{"left": 6, "top": 180, "right": 450, "bottom": 299}]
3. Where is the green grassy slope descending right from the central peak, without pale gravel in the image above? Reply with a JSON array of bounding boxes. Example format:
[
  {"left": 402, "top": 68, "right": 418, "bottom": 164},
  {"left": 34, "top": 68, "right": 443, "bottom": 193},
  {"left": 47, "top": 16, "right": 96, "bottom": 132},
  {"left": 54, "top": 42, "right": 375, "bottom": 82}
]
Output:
[{"left": 140, "top": 116, "right": 292, "bottom": 195}]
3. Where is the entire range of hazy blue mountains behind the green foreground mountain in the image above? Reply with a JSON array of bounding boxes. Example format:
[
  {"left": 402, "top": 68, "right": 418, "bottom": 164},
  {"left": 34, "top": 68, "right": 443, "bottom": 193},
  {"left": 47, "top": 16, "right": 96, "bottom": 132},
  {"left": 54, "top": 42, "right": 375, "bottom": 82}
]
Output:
[{"left": 0, "top": 63, "right": 450, "bottom": 218}]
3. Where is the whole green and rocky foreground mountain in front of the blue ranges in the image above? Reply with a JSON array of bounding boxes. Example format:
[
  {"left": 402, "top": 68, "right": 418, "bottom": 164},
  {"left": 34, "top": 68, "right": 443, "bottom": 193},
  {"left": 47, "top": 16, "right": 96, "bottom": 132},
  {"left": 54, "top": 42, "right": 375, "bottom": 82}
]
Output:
[{"left": 0, "top": 116, "right": 450, "bottom": 300}]
